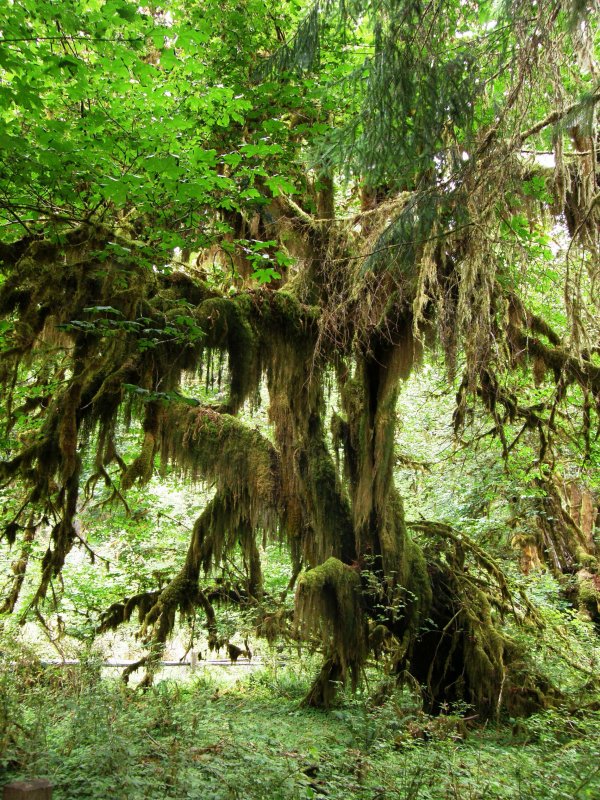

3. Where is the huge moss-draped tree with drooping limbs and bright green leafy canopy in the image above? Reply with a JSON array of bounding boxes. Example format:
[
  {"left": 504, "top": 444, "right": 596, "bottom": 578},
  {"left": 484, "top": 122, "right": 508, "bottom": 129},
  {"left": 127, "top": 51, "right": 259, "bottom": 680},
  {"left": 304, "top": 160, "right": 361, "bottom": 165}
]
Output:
[{"left": 0, "top": 0, "right": 600, "bottom": 714}]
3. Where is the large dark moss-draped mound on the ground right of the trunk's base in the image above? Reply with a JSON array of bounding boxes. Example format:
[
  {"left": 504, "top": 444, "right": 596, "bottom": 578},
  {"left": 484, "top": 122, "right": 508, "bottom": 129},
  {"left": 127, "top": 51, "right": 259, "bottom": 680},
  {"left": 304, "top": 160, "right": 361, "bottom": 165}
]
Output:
[{"left": 398, "top": 523, "right": 558, "bottom": 718}]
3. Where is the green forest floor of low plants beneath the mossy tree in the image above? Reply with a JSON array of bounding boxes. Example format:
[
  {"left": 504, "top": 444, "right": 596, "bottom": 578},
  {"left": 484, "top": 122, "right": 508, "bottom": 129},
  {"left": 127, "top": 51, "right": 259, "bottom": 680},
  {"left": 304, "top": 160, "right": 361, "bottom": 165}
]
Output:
[{"left": 0, "top": 662, "right": 600, "bottom": 800}]
